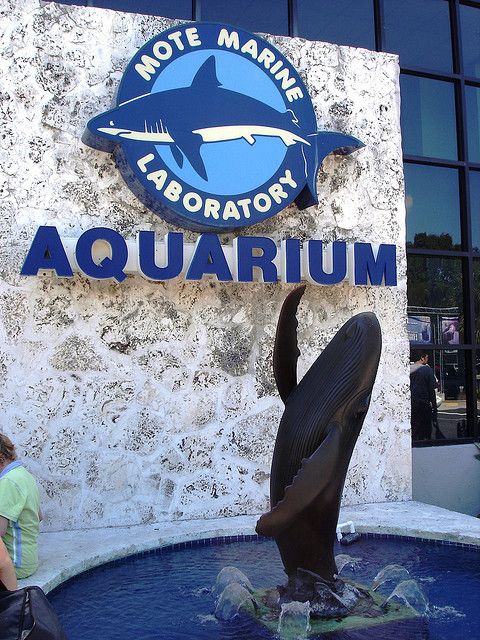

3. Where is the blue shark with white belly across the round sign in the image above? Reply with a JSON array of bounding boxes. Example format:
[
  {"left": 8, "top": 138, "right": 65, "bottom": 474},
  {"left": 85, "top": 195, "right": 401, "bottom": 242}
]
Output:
[{"left": 83, "top": 55, "right": 364, "bottom": 208}]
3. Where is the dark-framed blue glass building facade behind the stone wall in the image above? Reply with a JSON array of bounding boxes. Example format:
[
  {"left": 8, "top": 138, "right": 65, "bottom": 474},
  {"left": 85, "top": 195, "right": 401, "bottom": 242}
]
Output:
[{"left": 50, "top": 0, "right": 480, "bottom": 445}]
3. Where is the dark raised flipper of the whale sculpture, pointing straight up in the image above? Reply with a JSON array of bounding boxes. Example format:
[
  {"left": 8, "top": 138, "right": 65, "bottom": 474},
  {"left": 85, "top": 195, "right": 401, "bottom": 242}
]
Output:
[{"left": 273, "top": 285, "right": 305, "bottom": 402}]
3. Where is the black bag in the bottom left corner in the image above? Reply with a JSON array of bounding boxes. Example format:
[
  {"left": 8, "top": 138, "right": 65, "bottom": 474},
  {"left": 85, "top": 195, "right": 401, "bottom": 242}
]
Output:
[{"left": 0, "top": 583, "right": 67, "bottom": 640}]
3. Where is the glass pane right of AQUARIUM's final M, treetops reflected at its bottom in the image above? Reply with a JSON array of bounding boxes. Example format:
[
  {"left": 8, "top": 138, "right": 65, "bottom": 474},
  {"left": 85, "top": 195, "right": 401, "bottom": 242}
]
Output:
[{"left": 404, "top": 163, "right": 461, "bottom": 250}]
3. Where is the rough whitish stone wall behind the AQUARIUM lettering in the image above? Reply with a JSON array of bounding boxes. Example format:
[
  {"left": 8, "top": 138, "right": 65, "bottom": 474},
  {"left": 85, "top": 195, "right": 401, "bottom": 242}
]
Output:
[{"left": 0, "top": 0, "right": 411, "bottom": 530}]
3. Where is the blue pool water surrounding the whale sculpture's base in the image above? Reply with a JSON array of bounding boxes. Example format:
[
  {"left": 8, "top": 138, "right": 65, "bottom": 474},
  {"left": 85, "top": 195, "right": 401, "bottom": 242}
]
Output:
[{"left": 49, "top": 536, "right": 480, "bottom": 640}]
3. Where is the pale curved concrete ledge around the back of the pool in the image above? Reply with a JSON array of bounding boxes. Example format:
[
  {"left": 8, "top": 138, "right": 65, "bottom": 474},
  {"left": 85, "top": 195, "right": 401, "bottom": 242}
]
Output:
[{"left": 20, "top": 502, "right": 480, "bottom": 592}]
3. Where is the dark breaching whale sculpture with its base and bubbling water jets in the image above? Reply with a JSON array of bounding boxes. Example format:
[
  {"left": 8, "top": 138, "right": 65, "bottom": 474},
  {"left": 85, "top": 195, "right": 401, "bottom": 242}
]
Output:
[{"left": 216, "top": 286, "right": 428, "bottom": 637}]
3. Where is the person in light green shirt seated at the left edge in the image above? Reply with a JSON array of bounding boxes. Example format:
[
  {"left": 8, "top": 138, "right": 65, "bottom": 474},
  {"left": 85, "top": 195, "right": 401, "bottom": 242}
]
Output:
[{"left": 0, "top": 433, "right": 41, "bottom": 579}]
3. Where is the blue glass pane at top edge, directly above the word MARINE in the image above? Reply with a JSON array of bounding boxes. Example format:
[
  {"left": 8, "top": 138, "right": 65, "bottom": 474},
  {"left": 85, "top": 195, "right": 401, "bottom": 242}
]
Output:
[{"left": 200, "top": 0, "right": 288, "bottom": 35}]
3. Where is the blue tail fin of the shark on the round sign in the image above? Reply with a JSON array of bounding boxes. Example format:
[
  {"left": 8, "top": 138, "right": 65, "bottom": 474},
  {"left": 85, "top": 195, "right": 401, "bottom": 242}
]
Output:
[{"left": 295, "top": 131, "right": 365, "bottom": 209}]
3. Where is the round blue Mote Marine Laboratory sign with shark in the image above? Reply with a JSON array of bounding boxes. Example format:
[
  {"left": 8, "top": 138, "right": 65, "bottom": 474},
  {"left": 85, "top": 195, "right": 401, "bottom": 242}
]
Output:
[{"left": 83, "top": 23, "right": 363, "bottom": 231}]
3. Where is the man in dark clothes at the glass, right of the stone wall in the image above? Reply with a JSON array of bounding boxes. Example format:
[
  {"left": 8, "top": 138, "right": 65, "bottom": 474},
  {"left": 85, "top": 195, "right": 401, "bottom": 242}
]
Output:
[{"left": 410, "top": 350, "right": 437, "bottom": 440}]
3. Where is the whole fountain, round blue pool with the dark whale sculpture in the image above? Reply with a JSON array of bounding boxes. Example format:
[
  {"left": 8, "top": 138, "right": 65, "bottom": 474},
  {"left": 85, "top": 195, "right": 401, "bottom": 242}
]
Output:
[{"left": 45, "top": 288, "right": 480, "bottom": 640}]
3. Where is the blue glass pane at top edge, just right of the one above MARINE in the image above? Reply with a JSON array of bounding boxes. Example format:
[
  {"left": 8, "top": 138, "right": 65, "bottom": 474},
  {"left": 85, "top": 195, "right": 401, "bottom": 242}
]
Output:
[{"left": 297, "top": 0, "right": 375, "bottom": 50}]
